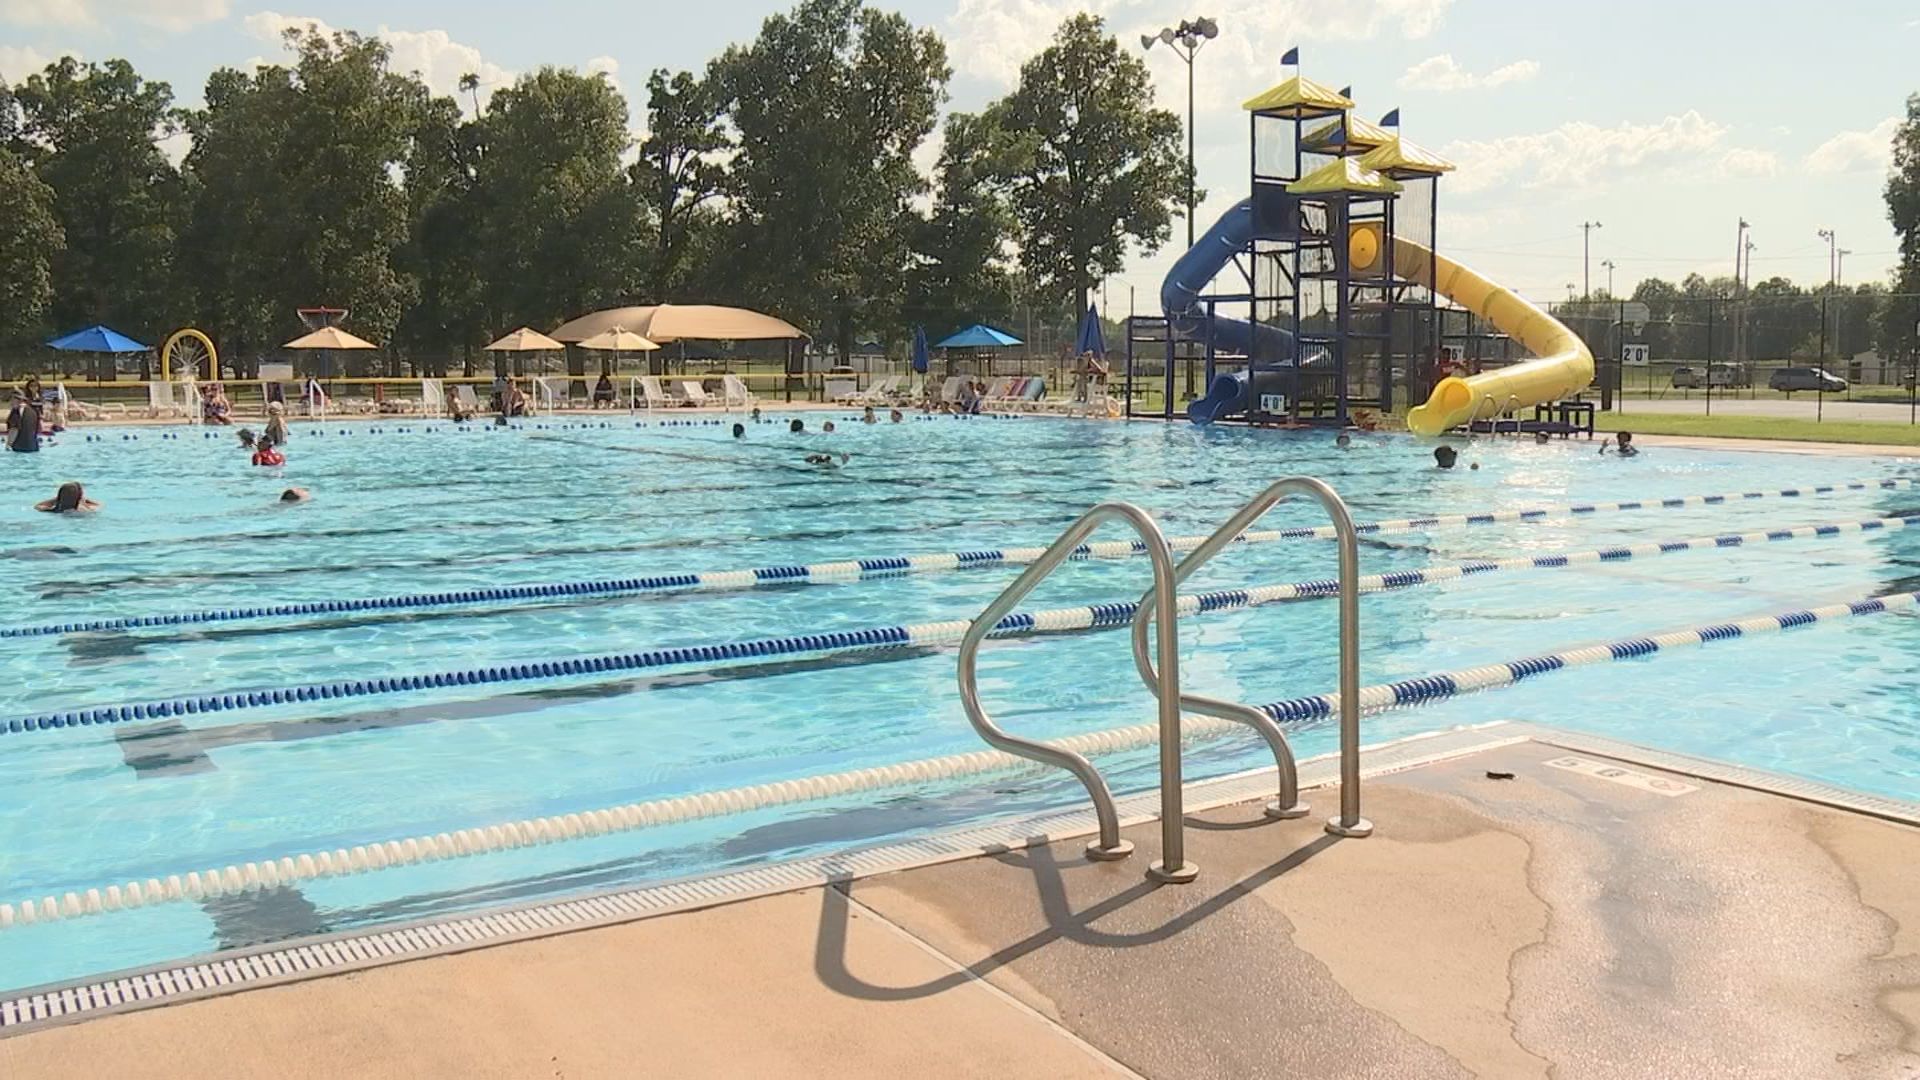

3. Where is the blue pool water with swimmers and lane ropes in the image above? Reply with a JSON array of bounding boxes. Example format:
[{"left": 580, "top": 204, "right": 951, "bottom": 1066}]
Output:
[{"left": 0, "top": 415, "right": 1920, "bottom": 988}]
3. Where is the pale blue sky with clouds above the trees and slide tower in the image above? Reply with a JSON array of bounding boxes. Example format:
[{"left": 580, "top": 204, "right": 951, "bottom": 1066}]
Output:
[{"left": 0, "top": 0, "right": 1920, "bottom": 315}]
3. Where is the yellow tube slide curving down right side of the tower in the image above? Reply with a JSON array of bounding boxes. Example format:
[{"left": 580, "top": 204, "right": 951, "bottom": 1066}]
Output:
[{"left": 1382, "top": 231, "right": 1594, "bottom": 436}]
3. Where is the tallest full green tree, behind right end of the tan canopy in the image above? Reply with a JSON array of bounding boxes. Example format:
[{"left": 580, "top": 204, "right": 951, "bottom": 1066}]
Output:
[{"left": 708, "top": 0, "right": 950, "bottom": 357}]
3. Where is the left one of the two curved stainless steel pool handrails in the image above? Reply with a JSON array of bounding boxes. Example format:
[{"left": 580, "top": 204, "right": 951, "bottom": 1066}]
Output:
[{"left": 960, "top": 502, "right": 1190, "bottom": 860}]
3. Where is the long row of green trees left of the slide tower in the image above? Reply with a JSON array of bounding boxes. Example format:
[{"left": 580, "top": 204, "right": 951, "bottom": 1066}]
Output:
[{"left": 0, "top": 0, "right": 1187, "bottom": 373}]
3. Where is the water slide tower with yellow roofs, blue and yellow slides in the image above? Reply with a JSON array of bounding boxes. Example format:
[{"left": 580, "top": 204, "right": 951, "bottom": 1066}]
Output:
[{"left": 1127, "top": 61, "right": 1594, "bottom": 428}]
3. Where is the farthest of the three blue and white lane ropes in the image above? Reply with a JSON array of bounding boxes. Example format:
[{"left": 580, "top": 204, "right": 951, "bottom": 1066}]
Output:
[{"left": 0, "top": 470, "right": 1920, "bottom": 638}]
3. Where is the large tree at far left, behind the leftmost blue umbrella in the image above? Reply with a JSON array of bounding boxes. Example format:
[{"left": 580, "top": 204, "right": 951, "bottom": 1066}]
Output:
[{"left": 15, "top": 56, "right": 184, "bottom": 336}]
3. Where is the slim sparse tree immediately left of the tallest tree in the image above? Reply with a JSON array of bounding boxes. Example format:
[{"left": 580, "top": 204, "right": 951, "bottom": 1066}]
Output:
[{"left": 632, "top": 69, "right": 733, "bottom": 302}]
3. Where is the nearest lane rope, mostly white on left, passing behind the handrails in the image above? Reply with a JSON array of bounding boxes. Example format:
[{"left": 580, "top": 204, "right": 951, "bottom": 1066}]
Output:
[{"left": 0, "top": 592, "right": 1920, "bottom": 930}]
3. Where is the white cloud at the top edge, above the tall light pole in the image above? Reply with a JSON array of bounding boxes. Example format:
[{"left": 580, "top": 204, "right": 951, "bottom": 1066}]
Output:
[{"left": 947, "top": 0, "right": 1453, "bottom": 88}]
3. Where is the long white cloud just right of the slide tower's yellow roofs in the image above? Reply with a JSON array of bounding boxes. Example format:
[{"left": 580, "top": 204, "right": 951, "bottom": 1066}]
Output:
[{"left": 1440, "top": 110, "right": 1772, "bottom": 194}]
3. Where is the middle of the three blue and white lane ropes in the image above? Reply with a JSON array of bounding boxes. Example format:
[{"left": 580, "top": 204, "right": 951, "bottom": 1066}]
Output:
[{"left": 0, "top": 515, "right": 1920, "bottom": 734}]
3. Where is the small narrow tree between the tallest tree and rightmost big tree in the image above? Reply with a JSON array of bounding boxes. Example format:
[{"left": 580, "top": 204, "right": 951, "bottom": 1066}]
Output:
[{"left": 902, "top": 113, "right": 1014, "bottom": 332}]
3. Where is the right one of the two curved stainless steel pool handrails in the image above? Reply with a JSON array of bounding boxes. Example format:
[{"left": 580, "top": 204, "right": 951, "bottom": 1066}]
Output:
[{"left": 1133, "top": 477, "right": 1373, "bottom": 849}]
